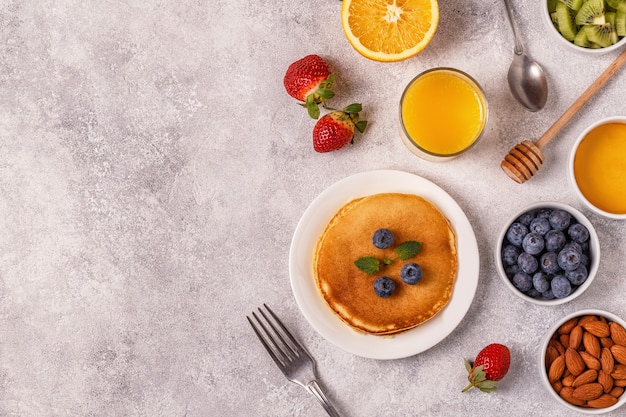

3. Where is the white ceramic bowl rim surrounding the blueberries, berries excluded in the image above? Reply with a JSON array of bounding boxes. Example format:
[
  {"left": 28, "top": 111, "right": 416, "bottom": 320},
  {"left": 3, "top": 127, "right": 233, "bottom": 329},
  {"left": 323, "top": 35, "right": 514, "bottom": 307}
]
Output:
[{"left": 495, "top": 202, "right": 600, "bottom": 306}]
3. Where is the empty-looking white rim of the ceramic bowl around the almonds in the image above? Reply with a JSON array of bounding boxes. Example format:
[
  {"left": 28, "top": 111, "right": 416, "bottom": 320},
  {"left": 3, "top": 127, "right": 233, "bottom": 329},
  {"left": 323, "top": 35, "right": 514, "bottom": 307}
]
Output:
[{"left": 538, "top": 309, "right": 626, "bottom": 415}]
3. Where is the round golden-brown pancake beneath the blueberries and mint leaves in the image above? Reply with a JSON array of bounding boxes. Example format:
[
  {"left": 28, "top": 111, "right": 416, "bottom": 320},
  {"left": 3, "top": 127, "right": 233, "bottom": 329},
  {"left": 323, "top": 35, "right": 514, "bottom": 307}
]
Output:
[{"left": 313, "top": 193, "right": 458, "bottom": 335}]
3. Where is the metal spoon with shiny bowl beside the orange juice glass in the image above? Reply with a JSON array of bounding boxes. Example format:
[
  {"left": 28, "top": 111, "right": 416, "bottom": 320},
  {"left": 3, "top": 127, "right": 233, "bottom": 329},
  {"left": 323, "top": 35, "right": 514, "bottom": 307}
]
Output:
[{"left": 504, "top": 0, "right": 548, "bottom": 112}]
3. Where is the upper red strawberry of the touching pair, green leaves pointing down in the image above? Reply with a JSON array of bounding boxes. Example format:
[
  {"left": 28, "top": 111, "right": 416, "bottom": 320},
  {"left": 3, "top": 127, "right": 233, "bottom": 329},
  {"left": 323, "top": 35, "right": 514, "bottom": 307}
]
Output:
[{"left": 283, "top": 55, "right": 335, "bottom": 119}]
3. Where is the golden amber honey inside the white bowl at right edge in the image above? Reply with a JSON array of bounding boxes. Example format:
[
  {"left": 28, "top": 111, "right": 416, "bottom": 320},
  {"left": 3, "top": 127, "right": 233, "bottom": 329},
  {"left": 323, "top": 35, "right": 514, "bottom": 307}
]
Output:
[{"left": 574, "top": 122, "right": 626, "bottom": 214}]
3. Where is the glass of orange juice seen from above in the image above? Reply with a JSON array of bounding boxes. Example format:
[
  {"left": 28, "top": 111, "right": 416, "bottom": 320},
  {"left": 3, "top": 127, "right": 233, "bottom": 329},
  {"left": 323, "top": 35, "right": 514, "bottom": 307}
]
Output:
[{"left": 400, "top": 67, "right": 489, "bottom": 161}]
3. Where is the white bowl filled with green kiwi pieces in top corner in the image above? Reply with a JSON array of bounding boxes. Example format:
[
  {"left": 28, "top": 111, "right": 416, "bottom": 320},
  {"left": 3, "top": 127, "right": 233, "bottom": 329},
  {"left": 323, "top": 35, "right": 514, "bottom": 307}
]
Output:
[{"left": 541, "top": 0, "right": 626, "bottom": 54}]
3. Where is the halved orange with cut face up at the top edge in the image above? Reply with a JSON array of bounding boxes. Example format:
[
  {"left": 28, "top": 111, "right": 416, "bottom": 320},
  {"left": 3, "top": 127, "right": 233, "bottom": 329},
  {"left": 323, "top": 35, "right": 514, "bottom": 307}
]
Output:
[{"left": 341, "top": 0, "right": 439, "bottom": 62}]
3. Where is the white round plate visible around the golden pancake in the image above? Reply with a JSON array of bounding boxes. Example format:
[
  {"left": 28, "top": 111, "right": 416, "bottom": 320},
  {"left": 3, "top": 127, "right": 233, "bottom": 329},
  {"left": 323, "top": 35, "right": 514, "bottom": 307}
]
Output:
[{"left": 289, "top": 170, "right": 480, "bottom": 359}]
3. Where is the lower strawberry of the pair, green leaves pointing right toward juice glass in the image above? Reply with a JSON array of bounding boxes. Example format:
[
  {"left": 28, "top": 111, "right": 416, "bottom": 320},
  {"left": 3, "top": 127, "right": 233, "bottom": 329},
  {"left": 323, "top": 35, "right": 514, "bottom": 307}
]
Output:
[{"left": 313, "top": 103, "right": 367, "bottom": 153}]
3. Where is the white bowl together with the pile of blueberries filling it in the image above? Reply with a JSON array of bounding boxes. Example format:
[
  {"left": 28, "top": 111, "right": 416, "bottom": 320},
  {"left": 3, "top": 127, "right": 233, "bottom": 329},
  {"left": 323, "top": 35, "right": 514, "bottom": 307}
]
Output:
[{"left": 495, "top": 202, "right": 600, "bottom": 305}]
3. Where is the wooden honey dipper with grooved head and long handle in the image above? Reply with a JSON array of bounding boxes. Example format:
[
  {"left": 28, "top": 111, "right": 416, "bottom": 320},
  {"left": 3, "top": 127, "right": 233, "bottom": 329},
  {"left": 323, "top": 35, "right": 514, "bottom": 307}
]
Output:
[{"left": 500, "top": 49, "right": 626, "bottom": 184}]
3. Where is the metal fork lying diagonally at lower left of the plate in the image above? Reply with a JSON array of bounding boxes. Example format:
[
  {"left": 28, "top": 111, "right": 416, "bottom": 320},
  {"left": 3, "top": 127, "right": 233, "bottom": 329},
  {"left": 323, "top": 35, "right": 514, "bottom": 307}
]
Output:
[{"left": 246, "top": 304, "right": 341, "bottom": 417}]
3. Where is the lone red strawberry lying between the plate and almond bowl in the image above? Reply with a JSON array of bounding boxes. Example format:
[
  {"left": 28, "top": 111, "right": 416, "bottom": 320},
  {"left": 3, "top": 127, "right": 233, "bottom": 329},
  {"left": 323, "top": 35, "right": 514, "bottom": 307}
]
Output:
[{"left": 463, "top": 343, "right": 511, "bottom": 392}]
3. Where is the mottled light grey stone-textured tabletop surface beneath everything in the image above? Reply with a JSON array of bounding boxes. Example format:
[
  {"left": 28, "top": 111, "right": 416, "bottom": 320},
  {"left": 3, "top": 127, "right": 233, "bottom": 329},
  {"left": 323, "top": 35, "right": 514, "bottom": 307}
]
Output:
[{"left": 0, "top": 0, "right": 626, "bottom": 417}]
